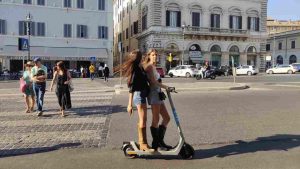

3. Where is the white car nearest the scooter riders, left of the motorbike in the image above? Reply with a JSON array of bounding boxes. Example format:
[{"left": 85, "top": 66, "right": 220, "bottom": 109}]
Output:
[{"left": 168, "top": 65, "right": 198, "bottom": 77}]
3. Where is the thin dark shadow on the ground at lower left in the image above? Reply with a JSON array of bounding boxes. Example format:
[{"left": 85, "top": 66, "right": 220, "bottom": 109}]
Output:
[{"left": 0, "top": 143, "right": 81, "bottom": 158}]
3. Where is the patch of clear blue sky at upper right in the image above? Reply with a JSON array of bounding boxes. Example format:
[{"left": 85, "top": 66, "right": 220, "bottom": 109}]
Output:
[{"left": 268, "top": 0, "right": 300, "bottom": 20}]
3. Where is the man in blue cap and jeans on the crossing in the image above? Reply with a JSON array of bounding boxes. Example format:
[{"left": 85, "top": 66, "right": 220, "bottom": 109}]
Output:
[{"left": 31, "top": 57, "right": 47, "bottom": 116}]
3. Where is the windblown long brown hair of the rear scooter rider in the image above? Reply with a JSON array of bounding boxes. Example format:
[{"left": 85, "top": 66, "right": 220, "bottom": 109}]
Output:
[{"left": 121, "top": 50, "right": 143, "bottom": 86}]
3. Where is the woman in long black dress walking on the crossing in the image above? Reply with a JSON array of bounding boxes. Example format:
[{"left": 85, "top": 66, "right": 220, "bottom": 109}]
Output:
[{"left": 50, "top": 61, "right": 72, "bottom": 117}]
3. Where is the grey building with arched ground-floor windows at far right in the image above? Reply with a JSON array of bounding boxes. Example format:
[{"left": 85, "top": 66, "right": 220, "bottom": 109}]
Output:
[{"left": 266, "top": 30, "right": 300, "bottom": 66}]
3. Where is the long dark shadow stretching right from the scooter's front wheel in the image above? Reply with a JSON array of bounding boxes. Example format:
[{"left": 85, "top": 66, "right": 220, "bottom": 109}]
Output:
[{"left": 194, "top": 134, "right": 300, "bottom": 159}]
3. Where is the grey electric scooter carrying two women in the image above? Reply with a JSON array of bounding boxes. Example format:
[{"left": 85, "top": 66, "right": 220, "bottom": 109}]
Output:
[{"left": 122, "top": 88, "right": 195, "bottom": 159}]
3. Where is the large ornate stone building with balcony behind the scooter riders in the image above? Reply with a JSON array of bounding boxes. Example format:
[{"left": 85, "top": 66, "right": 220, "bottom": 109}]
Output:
[{"left": 113, "top": 0, "right": 268, "bottom": 70}]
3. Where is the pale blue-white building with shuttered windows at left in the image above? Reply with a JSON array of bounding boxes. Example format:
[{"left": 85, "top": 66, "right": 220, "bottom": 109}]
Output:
[{"left": 0, "top": 0, "right": 113, "bottom": 72}]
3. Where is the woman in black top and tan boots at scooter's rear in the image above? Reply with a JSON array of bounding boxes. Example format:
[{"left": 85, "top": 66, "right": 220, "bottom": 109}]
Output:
[{"left": 121, "top": 50, "right": 154, "bottom": 152}]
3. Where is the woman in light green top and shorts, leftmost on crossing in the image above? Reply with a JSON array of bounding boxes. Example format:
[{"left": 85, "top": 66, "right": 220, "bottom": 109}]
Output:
[{"left": 22, "top": 61, "right": 35, "bottom": 113}]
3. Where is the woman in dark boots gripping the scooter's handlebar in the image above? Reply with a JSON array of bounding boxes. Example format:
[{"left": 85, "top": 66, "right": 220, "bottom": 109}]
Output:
[{"left": 144, "top": 49, "right": 172, "bottom": 150}]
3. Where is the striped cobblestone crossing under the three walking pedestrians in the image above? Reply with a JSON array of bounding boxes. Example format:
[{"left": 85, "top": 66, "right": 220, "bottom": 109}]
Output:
[{"left": 0, "top": 79, "right": 114, "bottom": 157}]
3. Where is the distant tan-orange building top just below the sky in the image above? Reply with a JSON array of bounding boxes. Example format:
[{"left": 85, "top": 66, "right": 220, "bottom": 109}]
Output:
[{"left": 267, "top": 18, "right": 300, "bottom": 35}]
